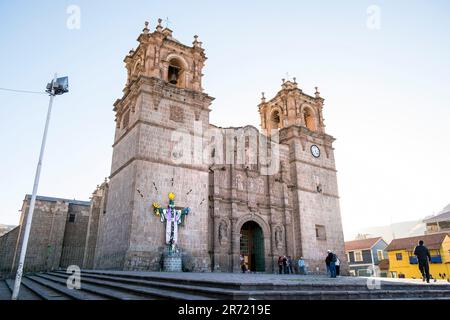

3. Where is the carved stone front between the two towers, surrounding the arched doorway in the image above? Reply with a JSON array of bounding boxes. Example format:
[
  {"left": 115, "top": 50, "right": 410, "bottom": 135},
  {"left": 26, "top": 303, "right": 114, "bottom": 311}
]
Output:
[{"left": 210, "top": 126, "right": 293, "bottom": 272}]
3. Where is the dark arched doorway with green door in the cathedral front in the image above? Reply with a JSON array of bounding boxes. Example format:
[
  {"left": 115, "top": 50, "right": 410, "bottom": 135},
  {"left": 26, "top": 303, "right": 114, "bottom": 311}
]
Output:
[{"left": 240, "top": 221, "right": 265, "bottom": 272}]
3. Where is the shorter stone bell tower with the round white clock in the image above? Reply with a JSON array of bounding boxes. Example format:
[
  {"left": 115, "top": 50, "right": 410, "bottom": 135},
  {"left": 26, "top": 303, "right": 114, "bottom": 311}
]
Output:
[{"left": 258, "top": 78, "right": 348, "bottom": 273}]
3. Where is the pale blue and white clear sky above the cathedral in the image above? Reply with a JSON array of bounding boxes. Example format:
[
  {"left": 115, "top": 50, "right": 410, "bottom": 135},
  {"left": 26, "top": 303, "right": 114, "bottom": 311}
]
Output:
[{"left": 0, "top": 0, "right": 450, "bottom": 238}]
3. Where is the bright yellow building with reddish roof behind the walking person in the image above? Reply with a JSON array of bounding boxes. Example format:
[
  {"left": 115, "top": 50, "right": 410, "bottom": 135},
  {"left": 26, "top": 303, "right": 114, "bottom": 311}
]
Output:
[{"left": 386, "top": 232, "right": 450, "bottom": 279}]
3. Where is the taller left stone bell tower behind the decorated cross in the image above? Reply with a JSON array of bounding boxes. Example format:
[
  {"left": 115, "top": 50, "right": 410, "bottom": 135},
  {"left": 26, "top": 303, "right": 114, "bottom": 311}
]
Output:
[{"left": 95, "top": 19, "right": 214, "bottom": 271}]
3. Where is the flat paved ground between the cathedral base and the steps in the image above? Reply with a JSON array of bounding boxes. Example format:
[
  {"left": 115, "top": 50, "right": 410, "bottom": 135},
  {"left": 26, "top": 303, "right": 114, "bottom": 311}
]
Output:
[{"left": 89, "top": 270, "right": 450, "bottom": 287}]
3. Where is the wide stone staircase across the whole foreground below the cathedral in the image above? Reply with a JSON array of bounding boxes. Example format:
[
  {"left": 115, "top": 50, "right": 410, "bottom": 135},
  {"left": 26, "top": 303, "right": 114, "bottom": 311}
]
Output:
[{"left": 0, "top": 270, "right": 450, "bottom": 300}]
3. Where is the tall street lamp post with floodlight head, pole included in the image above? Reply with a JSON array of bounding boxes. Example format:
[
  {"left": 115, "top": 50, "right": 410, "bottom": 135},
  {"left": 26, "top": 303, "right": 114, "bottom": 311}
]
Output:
[{"left": 11, "top": 74, "right": 69, "bottom": 300}]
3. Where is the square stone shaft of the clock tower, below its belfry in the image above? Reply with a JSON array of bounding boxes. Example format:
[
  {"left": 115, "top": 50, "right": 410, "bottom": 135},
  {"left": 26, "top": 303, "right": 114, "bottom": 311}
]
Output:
[{"left": 280, "top": 126, "right": 348, "bottom": 274}]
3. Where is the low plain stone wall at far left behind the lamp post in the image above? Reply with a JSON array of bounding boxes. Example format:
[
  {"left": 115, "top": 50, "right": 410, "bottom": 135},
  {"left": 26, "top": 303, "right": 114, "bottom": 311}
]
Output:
[{"left": 0, "top": 195, "right": 89, "bottom": 272}]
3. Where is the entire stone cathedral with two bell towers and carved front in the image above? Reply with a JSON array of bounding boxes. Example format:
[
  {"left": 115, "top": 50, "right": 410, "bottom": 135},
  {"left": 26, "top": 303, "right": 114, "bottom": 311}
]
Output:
[{"left": 90, "top": 22, "right": 347, "bottom": 273}]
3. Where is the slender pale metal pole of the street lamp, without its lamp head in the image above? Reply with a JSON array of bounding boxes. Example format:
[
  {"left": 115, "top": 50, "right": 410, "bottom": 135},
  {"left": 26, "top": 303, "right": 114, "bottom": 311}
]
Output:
[{"left": 11, "top": 74, "right": 57, "bottom": 300}]
